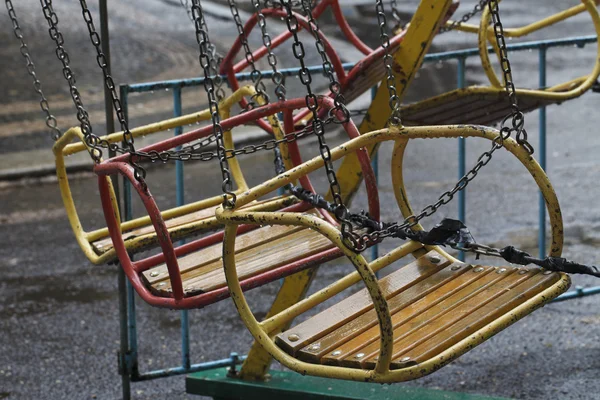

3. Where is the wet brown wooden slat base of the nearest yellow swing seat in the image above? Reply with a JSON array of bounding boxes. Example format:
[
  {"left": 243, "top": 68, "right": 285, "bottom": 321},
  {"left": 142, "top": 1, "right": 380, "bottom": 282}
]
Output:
[{"left": 275, "top": 253, "right": 561, "bottom": 370}]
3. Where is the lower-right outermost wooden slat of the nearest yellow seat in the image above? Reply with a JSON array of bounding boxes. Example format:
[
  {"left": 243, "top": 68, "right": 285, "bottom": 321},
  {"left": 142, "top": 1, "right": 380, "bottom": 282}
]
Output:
[{"left": 392, "top": 273, "right": 560, "bottom": 368}]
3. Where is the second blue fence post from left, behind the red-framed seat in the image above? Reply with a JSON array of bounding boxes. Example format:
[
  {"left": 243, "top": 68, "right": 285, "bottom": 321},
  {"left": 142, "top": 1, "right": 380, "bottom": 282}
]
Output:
[{"left": 173, "top": 87, "right": 191, "bottom": 369}]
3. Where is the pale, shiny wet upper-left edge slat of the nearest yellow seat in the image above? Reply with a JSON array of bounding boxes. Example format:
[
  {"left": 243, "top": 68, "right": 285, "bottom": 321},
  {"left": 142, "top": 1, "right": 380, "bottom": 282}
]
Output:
[{"left": 276, "top": 252, "right": 449, "bottom": 354}]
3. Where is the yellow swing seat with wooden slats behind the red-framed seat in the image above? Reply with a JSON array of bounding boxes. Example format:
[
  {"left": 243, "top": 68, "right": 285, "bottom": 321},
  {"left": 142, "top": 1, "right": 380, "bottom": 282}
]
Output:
[{"left": 53, "top": 86, "right": 297, "bottom": 264}]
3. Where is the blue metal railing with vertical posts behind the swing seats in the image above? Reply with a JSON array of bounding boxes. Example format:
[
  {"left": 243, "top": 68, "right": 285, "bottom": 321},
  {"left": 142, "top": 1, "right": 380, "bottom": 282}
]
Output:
[{"left": 120, "top": 36, "right": 600, "bottom": 390}]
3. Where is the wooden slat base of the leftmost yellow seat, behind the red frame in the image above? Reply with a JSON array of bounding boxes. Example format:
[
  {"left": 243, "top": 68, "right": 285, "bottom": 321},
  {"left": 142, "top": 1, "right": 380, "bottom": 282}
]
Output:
[{"left": 91, "top": 196, "right": 297, "bottom": 255}]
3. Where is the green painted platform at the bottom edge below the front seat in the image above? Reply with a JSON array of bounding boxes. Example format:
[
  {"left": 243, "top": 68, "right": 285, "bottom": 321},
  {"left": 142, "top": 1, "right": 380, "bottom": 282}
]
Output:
[{"left": 185, "top": 368, "right": 506, "bottom": 400}]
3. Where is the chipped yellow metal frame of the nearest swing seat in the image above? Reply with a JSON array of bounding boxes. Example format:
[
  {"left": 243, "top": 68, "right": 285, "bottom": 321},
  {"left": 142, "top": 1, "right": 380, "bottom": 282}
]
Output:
[{"left": 216, "top": 125, "right": 570, "bottom": 383}]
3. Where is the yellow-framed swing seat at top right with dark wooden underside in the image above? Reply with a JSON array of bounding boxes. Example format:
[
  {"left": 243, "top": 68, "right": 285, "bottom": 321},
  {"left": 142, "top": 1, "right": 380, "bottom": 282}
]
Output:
[{"left": 402, "top": 0, "right": 600, "bottom": 126}]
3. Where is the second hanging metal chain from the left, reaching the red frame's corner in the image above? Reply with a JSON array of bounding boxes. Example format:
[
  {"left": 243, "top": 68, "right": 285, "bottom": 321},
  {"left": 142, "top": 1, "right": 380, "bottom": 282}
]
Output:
[{"left": 40, "top": 0, "right": 102, "bottom": 163}]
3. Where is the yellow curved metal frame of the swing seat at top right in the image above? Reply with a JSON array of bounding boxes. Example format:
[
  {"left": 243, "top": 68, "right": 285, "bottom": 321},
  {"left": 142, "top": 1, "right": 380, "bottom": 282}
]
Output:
[{"left": 478, "top": 0, "right": 600, "bottom": 96}]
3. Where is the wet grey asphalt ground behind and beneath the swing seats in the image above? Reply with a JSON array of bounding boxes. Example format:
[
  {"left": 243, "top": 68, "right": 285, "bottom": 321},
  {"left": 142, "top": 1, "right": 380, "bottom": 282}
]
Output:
[{"left": 0, "top": 0, "right": 600, "bottom": 400}]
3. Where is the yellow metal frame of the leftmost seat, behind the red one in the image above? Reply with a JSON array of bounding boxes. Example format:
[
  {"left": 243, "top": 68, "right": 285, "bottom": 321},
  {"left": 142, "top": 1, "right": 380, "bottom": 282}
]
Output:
[{"left": 52, "top": 86, "right": 292, "bottom": 264}]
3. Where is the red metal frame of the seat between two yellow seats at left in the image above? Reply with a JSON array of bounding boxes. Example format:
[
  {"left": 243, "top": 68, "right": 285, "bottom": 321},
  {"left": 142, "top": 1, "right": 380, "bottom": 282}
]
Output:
[{"left": 94, "top": 96, "right": 379, "bottom": 309}]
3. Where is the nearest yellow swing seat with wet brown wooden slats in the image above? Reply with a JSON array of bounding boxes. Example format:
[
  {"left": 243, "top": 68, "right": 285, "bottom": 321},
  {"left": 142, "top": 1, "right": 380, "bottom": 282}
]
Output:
[{"left": 216, "top": 125, "right": 570, "bottom": 383}]
